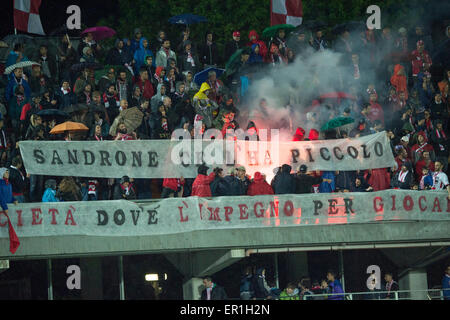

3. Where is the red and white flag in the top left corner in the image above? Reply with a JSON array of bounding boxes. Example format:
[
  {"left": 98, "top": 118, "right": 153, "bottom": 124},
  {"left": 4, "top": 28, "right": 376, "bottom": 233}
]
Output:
[{"left": 14, "top": 0, "right": 45, "bottom": 35}]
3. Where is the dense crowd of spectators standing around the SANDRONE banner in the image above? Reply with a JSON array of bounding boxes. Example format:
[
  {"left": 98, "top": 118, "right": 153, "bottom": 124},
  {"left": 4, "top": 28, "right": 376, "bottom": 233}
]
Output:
[{"left": 0, "top": 20, "right": 450, "bottom": 205}]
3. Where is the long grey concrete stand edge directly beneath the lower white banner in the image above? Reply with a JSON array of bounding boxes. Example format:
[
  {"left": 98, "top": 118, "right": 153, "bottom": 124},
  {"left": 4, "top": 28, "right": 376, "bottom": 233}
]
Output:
[{"left": 0, "top": 221, "right": 450, "bottom": 259}]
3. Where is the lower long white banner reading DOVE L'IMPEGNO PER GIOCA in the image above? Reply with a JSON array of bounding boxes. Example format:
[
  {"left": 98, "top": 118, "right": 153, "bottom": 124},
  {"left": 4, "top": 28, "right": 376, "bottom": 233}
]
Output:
[{"left": 0, "top": 190, "right": 450, "bottom": 240}]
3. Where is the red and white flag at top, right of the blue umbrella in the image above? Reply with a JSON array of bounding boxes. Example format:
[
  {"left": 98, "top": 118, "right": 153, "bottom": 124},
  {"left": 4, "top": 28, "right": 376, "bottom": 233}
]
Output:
[{"left": 270, "top": 0, "right": 303, "bottom": 27}]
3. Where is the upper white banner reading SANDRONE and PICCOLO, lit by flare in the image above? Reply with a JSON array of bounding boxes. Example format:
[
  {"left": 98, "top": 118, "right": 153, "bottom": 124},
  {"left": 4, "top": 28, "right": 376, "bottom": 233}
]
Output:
[{"left": 20, "top": 132, "right": 395, "bottom": 178}]
